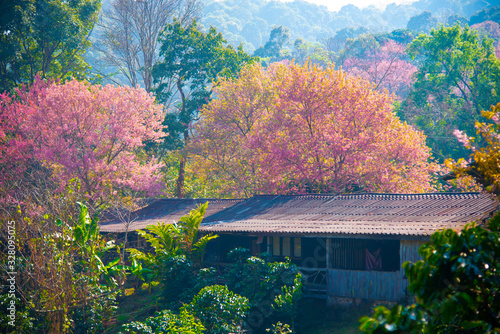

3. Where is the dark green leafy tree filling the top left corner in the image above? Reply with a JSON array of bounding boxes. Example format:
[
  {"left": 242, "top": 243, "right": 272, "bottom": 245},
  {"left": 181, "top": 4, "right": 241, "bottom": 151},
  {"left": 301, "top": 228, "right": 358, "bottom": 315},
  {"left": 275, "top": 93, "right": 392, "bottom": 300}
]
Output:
[{"left": 0, "top": 0, "right": 101, "bottom": 92}]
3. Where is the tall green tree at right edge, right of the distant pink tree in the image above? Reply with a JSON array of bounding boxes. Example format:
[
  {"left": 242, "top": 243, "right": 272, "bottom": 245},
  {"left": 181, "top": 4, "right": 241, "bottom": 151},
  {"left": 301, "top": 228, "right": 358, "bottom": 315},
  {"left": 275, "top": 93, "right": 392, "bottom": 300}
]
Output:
[{"left": 400, "top": 25, "right": 500, "bottom": 159}]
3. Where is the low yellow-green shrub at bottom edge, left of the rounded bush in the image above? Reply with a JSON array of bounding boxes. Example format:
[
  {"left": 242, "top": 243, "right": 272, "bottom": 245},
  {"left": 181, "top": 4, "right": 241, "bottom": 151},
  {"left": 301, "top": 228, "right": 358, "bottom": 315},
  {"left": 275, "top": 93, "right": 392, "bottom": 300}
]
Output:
[{"left": 122, "top": 310, "right": 205, "bottom": 334}]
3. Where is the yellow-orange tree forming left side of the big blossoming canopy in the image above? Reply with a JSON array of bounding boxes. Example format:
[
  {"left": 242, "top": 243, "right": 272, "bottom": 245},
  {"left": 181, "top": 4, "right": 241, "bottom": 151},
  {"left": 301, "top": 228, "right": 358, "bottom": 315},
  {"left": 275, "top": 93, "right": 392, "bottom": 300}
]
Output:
[{"left": 188, "top": 65, "right": 276, "bottom": 197}]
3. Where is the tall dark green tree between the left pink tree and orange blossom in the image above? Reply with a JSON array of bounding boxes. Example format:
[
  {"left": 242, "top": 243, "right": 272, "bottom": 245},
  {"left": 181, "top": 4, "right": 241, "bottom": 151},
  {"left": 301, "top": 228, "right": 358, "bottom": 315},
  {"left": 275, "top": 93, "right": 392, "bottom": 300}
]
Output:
[{"left": 152, "top": 21, "right": 253, "bottom": 197}]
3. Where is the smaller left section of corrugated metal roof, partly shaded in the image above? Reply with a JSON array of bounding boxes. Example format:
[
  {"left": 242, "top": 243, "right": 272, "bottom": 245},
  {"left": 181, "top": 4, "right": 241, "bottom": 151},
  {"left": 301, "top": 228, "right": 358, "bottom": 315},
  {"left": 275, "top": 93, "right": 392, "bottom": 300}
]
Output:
[{"left": 100, "top": 198, "right": 243, "bottom": 232}]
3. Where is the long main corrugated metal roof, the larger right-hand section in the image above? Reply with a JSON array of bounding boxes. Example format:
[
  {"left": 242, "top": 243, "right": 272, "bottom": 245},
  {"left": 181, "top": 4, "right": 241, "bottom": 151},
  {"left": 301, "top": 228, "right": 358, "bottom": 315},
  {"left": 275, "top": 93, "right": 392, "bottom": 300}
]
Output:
[{"left": 200, "top": 193, "right": 499, "bottom": 236}]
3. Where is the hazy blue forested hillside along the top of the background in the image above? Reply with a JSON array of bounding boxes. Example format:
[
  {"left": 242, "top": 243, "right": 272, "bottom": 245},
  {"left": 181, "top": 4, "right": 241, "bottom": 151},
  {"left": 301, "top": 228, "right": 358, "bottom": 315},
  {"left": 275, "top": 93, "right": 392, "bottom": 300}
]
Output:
[{"left": 201, "top": 0, "right": 497, "bottom": 53}]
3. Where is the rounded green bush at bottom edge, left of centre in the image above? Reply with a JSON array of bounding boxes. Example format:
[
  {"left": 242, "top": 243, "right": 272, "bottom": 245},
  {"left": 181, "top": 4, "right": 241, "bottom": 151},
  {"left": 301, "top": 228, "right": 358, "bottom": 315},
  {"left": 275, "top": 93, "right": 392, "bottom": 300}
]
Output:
[{"left": 182, "top": 285, "right": 249, "bottom": 333}]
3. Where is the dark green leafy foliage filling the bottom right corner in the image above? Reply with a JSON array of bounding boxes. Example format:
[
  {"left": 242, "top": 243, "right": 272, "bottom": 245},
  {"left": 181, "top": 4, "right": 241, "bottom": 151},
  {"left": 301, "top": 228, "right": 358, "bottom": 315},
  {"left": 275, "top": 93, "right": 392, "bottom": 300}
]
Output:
[{"left": 360, "top": 214, "right": 500, "bottom": 333}]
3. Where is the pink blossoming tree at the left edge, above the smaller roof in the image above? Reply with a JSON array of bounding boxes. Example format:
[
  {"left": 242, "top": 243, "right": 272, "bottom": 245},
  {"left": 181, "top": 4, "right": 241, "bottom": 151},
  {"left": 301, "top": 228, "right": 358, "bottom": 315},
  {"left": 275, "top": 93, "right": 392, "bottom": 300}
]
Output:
[{"left": 0, "top": 80, "right": 162, "bottom": 205}]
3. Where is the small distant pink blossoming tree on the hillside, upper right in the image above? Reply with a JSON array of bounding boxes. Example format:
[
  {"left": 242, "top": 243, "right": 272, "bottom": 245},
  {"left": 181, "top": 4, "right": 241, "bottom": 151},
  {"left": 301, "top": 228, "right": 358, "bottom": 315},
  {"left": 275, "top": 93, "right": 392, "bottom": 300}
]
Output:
[{"left": 343, "top": 40, "right": 417, "bottom": 98}]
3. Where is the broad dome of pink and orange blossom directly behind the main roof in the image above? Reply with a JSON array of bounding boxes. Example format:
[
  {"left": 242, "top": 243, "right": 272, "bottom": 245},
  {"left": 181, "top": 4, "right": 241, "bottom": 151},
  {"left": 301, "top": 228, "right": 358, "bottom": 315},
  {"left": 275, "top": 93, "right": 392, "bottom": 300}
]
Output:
[{"left": 191, "top": 63, "right": 433, "bottom": 196}]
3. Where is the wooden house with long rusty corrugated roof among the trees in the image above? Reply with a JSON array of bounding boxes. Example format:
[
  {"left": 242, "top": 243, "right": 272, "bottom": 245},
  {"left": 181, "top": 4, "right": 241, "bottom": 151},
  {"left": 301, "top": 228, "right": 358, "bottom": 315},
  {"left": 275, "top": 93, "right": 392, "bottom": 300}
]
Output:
[{"left": 101, "top": 193, "right": 499, "bottom": 303}]
